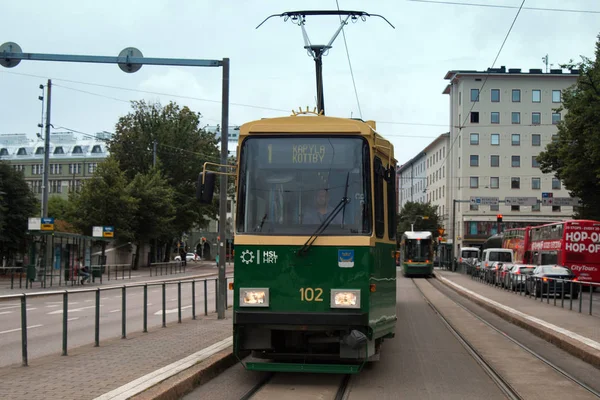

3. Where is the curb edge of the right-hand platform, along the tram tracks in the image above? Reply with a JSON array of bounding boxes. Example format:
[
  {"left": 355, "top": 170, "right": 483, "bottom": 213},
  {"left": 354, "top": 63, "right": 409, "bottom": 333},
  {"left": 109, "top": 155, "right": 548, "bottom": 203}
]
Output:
[{"left": 434, "top": 272, "right": 600, "bottom": 369}]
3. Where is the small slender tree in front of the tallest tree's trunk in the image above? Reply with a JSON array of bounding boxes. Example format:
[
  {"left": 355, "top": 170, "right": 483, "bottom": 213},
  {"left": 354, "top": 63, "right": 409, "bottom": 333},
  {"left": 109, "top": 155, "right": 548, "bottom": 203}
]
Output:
[{"left": 127, "top": 169, "right": 175, "bottom": 268}]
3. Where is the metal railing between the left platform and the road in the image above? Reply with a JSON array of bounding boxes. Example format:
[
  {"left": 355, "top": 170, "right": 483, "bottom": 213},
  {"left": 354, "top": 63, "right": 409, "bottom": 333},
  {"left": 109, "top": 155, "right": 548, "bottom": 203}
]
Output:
[{"left": 0, "top": 277, "right": 233, "bottom": 366}]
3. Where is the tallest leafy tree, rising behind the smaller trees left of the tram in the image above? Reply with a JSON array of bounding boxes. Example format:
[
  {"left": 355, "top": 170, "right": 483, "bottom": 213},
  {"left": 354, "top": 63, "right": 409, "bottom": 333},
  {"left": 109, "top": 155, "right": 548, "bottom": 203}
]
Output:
[{"left": 109, "top": 101, "right": 220, "bottom": 253}]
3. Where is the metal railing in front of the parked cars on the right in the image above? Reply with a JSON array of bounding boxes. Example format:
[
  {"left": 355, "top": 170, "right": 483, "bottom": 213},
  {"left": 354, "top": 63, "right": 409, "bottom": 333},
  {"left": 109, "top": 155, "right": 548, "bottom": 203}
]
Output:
[{"left": 459, "top": 265, "right": 600, "bottom": 315}]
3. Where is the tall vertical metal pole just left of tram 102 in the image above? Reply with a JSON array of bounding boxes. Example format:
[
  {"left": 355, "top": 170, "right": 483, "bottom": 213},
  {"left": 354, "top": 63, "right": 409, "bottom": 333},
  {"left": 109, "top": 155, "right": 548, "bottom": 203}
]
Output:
[{"left": 217, "top": 58, "right": 229, "bottom": 319}]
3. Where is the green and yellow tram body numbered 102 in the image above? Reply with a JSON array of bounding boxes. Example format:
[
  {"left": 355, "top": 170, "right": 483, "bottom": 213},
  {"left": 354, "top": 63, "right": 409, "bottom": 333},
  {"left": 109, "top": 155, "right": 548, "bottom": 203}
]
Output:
[{"left": 233, "top": 115, "right": 397, "bottom": 373}]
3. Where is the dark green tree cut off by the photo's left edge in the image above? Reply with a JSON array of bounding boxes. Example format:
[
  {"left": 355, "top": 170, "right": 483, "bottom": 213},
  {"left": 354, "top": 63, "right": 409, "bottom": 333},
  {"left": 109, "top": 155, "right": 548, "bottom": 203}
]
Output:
[{"left": 0, "top": 162, "right": 39, "bottom": 264}]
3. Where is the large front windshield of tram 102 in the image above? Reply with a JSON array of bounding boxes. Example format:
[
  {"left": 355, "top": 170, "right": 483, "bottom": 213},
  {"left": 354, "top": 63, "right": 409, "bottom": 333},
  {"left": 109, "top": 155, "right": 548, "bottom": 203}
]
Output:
[{"left": 236, "top": 136, "right": 371, "bottom": 235}]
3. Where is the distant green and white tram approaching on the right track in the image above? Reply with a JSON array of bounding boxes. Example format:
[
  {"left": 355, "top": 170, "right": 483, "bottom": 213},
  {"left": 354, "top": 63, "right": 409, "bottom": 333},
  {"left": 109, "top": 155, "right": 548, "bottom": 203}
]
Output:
[{"left": 400, "top": 231, "right": 433, "bottom": 276}]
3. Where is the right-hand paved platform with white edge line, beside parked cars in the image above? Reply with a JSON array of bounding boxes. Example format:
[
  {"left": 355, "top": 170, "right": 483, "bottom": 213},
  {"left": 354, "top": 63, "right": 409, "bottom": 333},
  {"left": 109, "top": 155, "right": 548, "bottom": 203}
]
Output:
[{"left": 434, "top": 269, "right": 600, "bottom": 368}]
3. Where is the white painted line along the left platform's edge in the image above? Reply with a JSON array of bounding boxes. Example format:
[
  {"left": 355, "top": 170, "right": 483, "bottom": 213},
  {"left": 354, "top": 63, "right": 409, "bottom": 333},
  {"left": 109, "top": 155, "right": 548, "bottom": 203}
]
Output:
[{"left": 94, "top": 336, "right": 233, "bottom": 400}]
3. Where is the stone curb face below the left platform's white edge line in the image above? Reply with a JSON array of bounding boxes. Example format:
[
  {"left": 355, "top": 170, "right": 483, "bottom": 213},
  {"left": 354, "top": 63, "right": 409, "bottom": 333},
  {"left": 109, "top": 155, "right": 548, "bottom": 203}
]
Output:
[{"left": 130, "top": 347, "right": 246, "bottom": 400}]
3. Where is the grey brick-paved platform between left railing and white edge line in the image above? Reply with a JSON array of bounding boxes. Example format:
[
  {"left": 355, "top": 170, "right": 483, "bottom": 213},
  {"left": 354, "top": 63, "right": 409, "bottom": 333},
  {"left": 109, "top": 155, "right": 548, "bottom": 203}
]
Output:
[{"left": 0, "top": 310, "right": 232, "bottom": 400}]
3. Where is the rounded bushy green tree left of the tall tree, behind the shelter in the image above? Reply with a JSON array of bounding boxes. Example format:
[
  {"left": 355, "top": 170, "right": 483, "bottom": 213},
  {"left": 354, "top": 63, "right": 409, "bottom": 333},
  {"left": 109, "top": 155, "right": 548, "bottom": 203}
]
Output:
[{"left": 71, "top": 157, "right": 138, "bottom": 242}]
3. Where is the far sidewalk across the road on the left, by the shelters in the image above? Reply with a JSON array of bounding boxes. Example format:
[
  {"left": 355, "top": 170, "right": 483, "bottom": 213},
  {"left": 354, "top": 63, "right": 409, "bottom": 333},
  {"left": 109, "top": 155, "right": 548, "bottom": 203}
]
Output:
[{"left": 0, "top": 261, "right": 233, "bottom": 296}]
